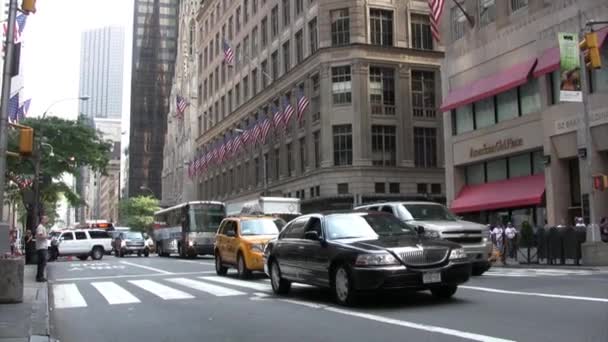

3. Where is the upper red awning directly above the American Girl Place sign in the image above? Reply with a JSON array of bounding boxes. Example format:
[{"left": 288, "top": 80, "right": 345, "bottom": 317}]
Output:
[{"left": 440, "top": 58, "right": 536, "bottom": 112}]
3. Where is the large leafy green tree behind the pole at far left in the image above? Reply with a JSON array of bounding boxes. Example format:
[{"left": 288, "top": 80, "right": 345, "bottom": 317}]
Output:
[{"left": 7, "top": 116, "right": 112, "bottom": 224}]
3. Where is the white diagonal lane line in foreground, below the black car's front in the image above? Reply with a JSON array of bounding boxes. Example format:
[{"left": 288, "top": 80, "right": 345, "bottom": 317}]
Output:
[{"left": 323, "top": 307, "right": 514, "bottom": 342}]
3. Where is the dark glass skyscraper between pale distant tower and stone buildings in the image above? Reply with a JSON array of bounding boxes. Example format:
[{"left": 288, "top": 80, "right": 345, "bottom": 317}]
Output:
[{"left": 127, "top": 0, "right": 179, "bottom": 198}]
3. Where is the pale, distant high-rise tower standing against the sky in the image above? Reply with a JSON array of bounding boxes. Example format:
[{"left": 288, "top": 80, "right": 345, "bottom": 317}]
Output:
[{"left": 79, "top": 27, "right": 125, "bottom": 118}]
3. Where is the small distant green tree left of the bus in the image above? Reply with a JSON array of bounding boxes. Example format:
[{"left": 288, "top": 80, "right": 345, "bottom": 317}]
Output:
[{"left": 120, "top": 196, "right": 159, "bottom": 232}]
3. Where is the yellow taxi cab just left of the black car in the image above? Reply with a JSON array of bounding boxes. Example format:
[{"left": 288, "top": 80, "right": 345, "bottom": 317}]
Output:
[{"left": 214, "top": 216, "right": 285, "bottom": 279}]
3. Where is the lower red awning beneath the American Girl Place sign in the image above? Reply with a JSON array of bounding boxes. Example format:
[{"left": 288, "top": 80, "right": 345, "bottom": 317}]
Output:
[{"left": 451, "top": 174, "right": 545, "bottom": 213}]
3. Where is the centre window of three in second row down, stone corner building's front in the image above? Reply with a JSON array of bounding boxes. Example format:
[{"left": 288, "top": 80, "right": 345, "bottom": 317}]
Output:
[{"left": 369, "top": 67, "right": 395, "bottom": 115}]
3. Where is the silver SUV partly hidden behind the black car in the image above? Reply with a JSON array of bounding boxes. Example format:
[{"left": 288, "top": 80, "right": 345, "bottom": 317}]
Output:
[{"left": 355, "top": 202, "right": 492, "bottom": 275}]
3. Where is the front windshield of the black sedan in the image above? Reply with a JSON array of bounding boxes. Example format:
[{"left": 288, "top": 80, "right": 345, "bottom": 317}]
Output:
[{"left": 327, "top": 214, "right": 415, "bottom": 240}]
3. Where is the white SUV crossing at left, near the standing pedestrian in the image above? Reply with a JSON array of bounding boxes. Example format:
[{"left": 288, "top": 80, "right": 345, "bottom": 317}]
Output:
[{"left": 50, "top": 229, "right": 112, "bottom": 260}]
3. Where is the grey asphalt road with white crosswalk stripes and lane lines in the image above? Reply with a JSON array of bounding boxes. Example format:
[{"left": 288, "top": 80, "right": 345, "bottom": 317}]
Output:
[{"left": 49, "top": 256, "right": 608, "bottom": 342}]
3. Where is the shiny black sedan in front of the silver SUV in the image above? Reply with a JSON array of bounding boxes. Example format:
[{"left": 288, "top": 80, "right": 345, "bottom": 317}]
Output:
[{"left": 264, "top": 212, "right": 471, "bottom": 304}]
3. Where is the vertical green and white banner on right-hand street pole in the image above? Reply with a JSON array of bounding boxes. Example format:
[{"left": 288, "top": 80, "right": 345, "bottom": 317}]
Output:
[{"left": 558, "top": 33, "right": 583, "bottom": 102}]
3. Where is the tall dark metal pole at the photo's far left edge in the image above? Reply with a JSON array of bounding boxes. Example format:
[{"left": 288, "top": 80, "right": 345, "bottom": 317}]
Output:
[{"left": 0, "top": 0, "right": 17, "bottom": 221}]
